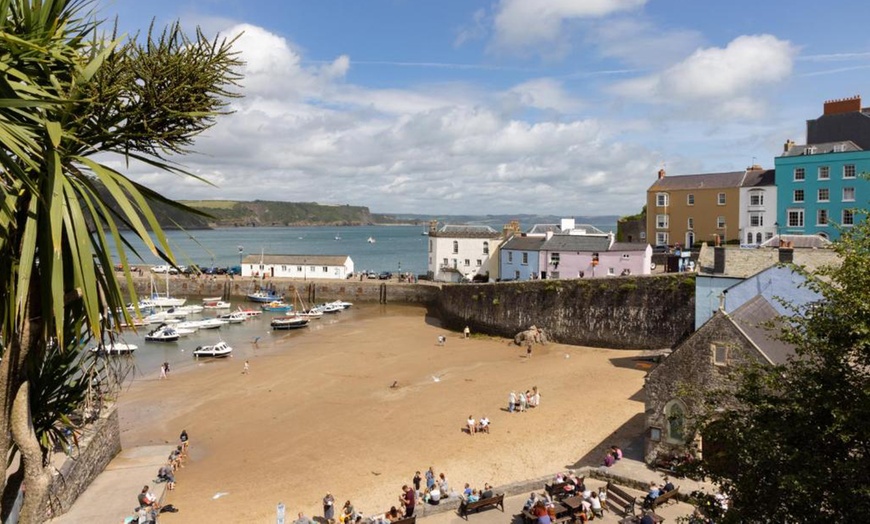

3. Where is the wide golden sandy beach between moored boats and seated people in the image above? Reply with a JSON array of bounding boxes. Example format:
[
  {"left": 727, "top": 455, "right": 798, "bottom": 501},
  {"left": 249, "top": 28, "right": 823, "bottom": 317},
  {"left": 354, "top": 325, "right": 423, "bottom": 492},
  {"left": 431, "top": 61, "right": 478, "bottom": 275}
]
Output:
[{"left": 120, "top": 305, "right": 646, "bottom": 523}]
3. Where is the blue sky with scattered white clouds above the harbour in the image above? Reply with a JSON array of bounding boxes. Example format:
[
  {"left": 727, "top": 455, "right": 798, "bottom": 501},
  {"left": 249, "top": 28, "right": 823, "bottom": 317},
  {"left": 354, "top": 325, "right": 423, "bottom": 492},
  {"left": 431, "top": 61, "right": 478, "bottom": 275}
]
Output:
[{"left": 99, "top": 0, "right": 870, "bottom": 217}]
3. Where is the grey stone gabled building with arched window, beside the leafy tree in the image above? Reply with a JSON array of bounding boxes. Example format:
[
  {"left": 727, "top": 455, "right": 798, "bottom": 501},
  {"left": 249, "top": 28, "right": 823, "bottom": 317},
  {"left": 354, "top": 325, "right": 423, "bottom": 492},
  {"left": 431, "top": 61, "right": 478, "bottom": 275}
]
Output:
[{"left": 644, "top": 289, "right": 794, "bottom": 465}]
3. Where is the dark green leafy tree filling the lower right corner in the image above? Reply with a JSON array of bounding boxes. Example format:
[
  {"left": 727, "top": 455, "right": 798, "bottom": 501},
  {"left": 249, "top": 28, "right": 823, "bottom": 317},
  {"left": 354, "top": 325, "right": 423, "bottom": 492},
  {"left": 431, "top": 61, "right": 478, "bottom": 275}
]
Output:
[{"left": 693, "top": 208, "right": 870, "bottom": 523}]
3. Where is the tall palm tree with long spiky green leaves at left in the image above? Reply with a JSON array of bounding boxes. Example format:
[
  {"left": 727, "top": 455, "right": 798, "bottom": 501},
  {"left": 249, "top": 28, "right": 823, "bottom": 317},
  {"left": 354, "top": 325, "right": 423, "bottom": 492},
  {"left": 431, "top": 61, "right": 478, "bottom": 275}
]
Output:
[{"left": 0, "top": 0, "right": 240, "bottom": 522}]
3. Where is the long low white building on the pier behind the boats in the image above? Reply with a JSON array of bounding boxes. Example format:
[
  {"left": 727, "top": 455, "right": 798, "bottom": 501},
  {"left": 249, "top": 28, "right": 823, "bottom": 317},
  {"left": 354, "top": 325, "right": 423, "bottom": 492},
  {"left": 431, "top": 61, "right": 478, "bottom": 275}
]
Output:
[{"left": 242, "top": 254, "right": 354, "bottom": 280}]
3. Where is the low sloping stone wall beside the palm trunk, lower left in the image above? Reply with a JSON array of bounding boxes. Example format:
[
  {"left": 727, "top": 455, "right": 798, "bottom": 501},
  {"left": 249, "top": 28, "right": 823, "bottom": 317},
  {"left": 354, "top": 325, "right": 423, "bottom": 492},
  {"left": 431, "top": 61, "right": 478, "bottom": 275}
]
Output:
[{"left": 46, "top": 406, "right": 121, "bottom": 518}]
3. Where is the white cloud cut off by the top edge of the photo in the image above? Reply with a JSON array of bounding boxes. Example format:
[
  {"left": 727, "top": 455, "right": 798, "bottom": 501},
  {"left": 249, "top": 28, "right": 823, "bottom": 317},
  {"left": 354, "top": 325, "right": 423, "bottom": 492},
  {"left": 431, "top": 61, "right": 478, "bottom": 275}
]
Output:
[{"left": 494, "top": 0, "right": 646, "bottom": 50}]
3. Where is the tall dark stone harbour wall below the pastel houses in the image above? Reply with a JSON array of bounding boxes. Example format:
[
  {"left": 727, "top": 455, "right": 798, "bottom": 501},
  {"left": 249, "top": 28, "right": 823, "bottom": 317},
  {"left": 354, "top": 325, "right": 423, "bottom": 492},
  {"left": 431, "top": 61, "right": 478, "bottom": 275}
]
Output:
[{"left": 437, "top": 274, "right": 695, "bottom": 349}]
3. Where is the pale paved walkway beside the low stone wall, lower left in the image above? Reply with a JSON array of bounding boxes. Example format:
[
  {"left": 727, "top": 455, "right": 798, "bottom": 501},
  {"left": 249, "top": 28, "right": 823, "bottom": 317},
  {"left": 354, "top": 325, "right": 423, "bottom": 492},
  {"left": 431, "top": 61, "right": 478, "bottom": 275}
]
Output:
[{"left": 49, "top": 444, "right": 175, "bottom": 524}]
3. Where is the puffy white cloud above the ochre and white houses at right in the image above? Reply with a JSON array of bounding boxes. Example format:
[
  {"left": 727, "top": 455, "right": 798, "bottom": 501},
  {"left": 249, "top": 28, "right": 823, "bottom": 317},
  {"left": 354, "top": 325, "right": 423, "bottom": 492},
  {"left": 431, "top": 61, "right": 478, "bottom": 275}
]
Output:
[{"left": 616, "top": 35, "right": 797, "bottom": 118}]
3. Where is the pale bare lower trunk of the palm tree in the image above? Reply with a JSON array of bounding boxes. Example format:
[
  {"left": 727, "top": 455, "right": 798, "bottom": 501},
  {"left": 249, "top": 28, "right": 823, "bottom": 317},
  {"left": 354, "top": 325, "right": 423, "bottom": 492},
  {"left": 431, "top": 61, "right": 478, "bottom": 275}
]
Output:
[{"left": 12, "top": 382, "right": 51, "bottom": 524}]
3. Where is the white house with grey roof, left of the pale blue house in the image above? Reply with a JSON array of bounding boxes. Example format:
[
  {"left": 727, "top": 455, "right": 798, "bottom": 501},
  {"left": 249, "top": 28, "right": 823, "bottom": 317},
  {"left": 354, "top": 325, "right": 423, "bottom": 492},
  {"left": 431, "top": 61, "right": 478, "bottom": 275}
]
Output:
[{"left": 428, "top": 221, "right": 504, "bottom": 282}]
